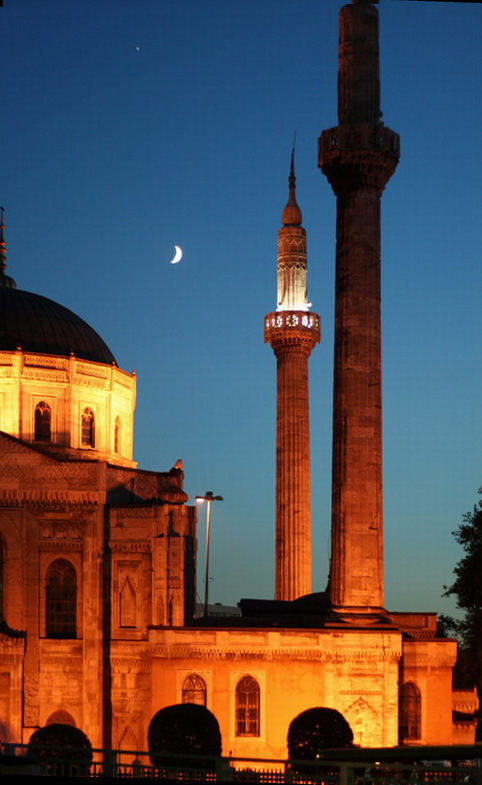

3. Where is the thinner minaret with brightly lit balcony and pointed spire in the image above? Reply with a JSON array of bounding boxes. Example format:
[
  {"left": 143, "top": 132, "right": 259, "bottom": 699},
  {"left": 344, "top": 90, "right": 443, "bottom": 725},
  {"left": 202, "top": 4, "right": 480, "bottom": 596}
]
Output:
[{"left": 264, "top": 156, "right": 320, "bottom": 600}]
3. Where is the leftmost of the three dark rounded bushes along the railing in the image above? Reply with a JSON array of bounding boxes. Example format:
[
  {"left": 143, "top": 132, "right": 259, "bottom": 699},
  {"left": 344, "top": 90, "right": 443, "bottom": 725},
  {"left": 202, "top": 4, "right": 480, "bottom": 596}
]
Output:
[{"left": 28, "top": 723, "right": 92, "bottom": 776}]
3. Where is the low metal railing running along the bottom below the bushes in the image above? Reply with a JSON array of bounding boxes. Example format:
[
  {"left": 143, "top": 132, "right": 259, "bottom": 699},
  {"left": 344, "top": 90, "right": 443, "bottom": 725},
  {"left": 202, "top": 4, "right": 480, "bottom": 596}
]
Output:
[{"left": 0, "top": 744, "right": 482, "bottom": 785}]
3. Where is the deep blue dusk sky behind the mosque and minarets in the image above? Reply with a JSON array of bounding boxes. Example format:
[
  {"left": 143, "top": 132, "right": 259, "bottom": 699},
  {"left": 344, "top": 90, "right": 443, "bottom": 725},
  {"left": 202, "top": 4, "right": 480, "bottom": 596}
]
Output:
[{"left": 0, "top": 0, "right": 482, "bottom": 612}]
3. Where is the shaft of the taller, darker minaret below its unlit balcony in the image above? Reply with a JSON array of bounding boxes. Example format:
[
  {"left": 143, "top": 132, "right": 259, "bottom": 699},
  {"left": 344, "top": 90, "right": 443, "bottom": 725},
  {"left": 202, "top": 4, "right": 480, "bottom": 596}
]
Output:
[{"left": 330, "top": 191, "right": 383, "bottom": 608}]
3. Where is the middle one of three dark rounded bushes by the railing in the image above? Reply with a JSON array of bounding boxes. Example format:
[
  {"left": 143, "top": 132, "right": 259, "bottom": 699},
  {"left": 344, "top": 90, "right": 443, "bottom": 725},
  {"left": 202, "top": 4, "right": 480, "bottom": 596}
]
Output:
[{"left": 147, "top": 703, "right": 221, "bottom": 769}]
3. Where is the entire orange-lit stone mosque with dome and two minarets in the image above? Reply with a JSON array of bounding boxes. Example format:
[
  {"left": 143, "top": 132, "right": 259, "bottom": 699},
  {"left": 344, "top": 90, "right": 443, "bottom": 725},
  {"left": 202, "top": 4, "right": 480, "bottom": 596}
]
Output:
[{"left": 0, "top": 0, "right": 476, "bottom": 758}]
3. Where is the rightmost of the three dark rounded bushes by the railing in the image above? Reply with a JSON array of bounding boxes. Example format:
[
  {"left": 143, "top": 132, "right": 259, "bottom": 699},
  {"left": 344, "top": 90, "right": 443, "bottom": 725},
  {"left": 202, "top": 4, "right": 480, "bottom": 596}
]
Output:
[{"left": 288, "top": 708, "right": 353, "bottom": 773}]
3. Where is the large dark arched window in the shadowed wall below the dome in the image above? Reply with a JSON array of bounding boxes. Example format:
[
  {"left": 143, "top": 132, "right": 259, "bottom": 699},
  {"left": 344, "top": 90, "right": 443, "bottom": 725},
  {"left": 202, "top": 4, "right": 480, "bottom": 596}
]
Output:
[{"left": 45, "top": 559, "right": 77, "bottom": 638}]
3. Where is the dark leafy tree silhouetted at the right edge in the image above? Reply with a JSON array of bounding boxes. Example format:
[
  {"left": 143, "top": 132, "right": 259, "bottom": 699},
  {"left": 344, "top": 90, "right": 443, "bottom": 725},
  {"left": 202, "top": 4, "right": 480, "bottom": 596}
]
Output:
[{"left": 442, "top": 488, "right": 482, "bottom": 741}]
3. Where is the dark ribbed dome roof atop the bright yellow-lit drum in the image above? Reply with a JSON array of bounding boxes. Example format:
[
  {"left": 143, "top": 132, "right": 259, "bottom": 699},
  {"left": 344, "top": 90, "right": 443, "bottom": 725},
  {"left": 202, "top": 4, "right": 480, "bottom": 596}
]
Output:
[{"left": 0, "top": 286, "right": 116, "bottom": 365}]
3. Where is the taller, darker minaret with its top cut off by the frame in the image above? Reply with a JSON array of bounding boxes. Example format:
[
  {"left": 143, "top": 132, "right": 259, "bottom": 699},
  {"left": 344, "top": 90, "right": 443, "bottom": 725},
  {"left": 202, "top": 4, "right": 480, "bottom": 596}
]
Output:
[{"left": 319, "top": 0, "right": 399, "bottom": 616}]
